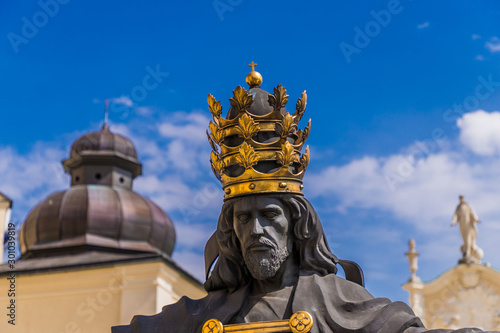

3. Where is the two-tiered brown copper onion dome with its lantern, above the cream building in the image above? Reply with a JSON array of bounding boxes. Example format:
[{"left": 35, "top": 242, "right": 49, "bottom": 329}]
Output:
[{"left": 19, "top": 124, "right": 175, "bottom": 258}]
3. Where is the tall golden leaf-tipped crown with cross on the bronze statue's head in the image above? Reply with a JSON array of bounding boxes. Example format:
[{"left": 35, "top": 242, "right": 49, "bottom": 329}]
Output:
[{"left": 207, "top": 61, "right": 311, "bottom": 200}]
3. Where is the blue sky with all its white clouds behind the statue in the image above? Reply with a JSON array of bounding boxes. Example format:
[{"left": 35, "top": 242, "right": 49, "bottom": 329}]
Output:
[{"left": 0, "top": 0, "right": 500, "bottom": 301}]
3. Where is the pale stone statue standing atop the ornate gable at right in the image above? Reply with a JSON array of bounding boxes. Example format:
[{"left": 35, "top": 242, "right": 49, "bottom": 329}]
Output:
[{"left": 451, "top": 195, "right": 483, "bottom": 264}]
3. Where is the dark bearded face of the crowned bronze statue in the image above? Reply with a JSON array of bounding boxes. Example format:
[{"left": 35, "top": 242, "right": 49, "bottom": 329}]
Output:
[{"left": 233, "top": 196, "right": 293, "bottom": 280}]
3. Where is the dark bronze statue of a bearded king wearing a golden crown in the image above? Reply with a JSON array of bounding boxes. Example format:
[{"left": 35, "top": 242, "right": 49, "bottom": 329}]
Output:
[{"left": 113, "top": 62, "right": 496, "bottom": 333}]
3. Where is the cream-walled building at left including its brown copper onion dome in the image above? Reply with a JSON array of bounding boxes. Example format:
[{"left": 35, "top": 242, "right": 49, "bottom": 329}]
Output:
[{"left": 0, "top": 125, "right": 205, "bottom": 333}]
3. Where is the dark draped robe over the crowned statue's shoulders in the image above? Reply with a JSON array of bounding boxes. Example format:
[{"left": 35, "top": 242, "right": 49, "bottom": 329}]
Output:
[{"left": 112, "top": 272, "right": 481, "bottom": 333}]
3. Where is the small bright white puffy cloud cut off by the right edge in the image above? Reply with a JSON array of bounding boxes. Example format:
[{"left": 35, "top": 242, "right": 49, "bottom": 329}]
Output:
[{"left": 457, "top": 110, "right": 500, "bottom": 156}]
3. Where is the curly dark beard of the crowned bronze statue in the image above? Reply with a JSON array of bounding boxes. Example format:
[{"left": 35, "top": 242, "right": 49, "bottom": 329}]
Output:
[{"left": 245, "top": 239, "right": 290, "bottom": 280}]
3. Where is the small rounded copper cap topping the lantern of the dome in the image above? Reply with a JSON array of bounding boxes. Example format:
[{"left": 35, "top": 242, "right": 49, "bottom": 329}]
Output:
[{"left": 70, "top": 125, "right": 137, "bottom": 159}]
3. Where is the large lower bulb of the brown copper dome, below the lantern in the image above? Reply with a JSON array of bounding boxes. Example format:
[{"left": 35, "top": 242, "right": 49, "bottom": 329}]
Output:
[{"left": 20, "top": 184, "right": 175, "bottom": 257}]
